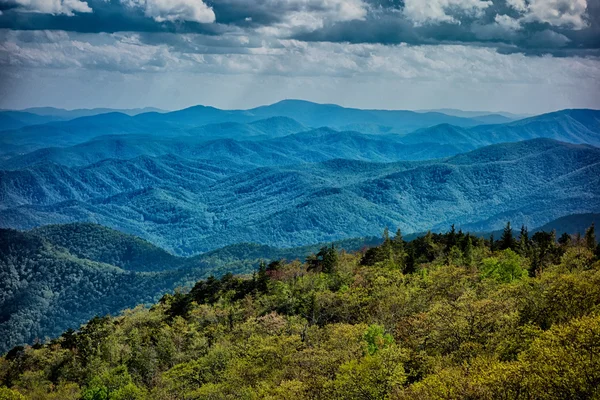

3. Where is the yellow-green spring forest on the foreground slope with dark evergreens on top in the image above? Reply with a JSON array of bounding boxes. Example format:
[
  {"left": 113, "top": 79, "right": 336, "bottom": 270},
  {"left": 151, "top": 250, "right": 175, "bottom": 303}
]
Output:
[{"left": 0, "top": 225, "right": 600, "bottom": 400}]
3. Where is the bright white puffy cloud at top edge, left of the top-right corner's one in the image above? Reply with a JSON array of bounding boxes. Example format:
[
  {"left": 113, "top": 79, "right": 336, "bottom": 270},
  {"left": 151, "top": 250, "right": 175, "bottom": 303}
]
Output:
[{"left": 403, "top": 0, "right": 493, "bottom": 25}]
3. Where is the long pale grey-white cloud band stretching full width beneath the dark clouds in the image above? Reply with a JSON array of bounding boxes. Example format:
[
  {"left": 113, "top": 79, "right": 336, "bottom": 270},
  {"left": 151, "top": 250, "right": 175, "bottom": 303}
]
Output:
[{"left": 0, "top": 31, "right": 600, "bottom": 90}]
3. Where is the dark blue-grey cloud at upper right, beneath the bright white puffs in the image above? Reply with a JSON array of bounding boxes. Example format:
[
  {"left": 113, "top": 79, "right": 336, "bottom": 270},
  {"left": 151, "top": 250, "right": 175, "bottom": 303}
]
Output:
[{"left": 293, "top": 0, "right": 600, "bottom": 56}]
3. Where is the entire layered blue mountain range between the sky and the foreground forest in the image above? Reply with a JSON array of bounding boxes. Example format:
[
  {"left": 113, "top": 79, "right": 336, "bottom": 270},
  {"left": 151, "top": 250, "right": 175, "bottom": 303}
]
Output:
[{"left": 0, "top": 100, "right": 600, "bottom": 351}]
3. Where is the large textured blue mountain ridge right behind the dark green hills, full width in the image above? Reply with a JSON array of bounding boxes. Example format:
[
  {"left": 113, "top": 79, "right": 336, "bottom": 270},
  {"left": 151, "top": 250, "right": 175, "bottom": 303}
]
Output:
[{"left": 0, "top": 139, "right": 600, "bottom": 254}]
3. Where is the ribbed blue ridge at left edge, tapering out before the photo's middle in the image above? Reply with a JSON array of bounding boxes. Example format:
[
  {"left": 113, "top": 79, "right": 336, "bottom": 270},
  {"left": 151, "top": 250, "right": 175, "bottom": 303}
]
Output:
[{"left": 0, "top": 155, "right": 243, "bottom": 208}]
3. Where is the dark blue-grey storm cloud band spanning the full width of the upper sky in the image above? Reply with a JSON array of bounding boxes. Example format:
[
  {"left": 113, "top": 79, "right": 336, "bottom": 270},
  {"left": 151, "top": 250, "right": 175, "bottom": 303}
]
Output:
[{"left": 0, "top": 0, "right": 600, "bottom": 56}]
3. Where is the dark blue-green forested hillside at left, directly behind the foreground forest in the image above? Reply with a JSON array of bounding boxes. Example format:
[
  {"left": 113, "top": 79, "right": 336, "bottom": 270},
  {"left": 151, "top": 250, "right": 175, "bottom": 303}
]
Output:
[{"left": 0, "top": 224, "right": 380, "bottom": 352}]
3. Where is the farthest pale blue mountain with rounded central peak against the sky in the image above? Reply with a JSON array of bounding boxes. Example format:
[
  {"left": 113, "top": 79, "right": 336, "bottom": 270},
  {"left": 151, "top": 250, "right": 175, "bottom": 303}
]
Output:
[{"left": 0, "top": 100, "right": 496, "bottom": 153}]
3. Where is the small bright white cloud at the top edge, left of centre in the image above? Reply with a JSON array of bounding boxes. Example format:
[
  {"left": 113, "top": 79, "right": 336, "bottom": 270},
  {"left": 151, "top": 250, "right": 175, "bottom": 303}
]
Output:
[{"left": 121, "top": 0, "right": 215, "bottom": 23}]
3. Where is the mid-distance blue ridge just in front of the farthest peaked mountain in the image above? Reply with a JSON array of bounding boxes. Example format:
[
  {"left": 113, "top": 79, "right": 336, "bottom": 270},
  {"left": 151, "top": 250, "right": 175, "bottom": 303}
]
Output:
[{"left": 0, "top": 125, "right": 464, "bottom": 170}]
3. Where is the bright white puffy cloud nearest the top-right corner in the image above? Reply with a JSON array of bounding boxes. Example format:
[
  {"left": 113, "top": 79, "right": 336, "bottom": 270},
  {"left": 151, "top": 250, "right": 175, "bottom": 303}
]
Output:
[{"left": 507, "top": 0, "right": 588, "bottom": 30}]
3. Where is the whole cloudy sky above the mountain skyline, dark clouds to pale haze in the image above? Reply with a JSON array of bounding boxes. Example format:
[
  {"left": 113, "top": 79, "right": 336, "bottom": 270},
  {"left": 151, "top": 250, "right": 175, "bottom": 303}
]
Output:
[{"left": 0, "top": 0, "right": 600, "bottom": 114}]
